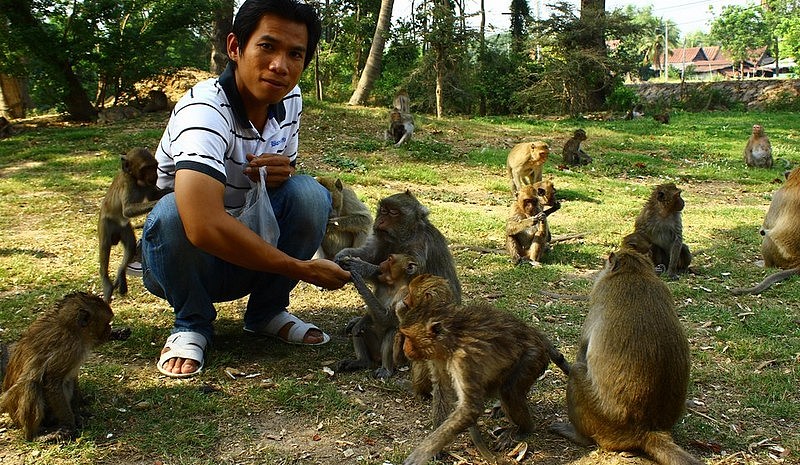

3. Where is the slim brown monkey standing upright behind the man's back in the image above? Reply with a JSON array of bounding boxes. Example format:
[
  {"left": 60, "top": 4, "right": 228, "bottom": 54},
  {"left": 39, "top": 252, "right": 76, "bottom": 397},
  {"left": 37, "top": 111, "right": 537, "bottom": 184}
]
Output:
[{"left": 97, "top": 147, "right": 171, "bottom": 302}]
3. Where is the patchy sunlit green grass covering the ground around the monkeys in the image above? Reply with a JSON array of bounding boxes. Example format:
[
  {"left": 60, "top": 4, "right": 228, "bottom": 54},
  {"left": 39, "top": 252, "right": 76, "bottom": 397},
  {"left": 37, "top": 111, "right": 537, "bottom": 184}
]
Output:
[{"left": 0, "top": 108, "right": 800, "bottom": 465}]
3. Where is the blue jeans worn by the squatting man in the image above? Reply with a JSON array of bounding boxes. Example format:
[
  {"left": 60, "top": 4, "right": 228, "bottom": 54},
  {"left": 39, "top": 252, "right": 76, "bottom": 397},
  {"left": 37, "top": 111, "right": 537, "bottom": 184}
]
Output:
[{"left": 142, "top": 175, "right": 331, "bottom": 341}]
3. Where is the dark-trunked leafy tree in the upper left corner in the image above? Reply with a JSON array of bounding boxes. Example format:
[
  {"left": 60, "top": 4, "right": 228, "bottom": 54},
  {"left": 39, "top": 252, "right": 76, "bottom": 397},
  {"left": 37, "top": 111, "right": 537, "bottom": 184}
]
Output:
[{"left": 0, "top": 0, "right": 216, "bottom": 121}]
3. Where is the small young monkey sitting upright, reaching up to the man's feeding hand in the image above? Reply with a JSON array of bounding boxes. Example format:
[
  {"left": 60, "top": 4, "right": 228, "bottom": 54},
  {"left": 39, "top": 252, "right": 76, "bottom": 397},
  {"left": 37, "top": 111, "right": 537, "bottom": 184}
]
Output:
[{"left": 338, "top": 254, "right": 419, "bottom": 379}]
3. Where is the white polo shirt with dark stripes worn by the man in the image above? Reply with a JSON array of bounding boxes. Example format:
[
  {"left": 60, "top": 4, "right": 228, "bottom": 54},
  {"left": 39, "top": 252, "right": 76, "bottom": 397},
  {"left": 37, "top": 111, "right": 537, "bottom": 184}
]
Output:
[{"left": 156, "top": 65, "right": 303, "bottom": 209}]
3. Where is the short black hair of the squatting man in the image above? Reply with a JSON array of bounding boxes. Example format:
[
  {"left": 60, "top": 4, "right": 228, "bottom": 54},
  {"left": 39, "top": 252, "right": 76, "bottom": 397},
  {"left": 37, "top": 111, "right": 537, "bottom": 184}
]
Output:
[{"left": 231, "top": 0, "right": 322, "bottom": 68}]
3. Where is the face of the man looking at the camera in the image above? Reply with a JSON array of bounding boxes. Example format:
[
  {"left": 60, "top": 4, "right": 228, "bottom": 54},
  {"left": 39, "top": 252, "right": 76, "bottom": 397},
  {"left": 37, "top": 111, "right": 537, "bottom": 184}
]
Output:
[{"left": 228, "top": 14, "right": 312, "bottom": 106}]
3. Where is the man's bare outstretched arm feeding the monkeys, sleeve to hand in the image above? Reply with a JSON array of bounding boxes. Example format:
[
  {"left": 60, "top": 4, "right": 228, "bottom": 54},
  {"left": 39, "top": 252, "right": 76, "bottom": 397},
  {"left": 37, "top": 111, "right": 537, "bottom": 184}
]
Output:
[{"left": 175, "top": 169, "right": 350, "bottom": 289}]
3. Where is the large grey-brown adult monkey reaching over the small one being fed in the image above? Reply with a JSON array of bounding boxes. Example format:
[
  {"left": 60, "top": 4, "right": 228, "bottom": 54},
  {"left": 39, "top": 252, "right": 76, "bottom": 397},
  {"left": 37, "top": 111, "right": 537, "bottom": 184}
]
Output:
[{"left": 334, "top": 190, "right": 461, "bottom": 398}]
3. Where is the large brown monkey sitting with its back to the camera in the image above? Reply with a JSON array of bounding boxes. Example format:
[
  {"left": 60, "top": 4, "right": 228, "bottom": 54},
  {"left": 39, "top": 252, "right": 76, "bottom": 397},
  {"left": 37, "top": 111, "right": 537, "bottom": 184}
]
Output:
[{"left": 550, "top": 246, "right": 702, "bottom": 465}]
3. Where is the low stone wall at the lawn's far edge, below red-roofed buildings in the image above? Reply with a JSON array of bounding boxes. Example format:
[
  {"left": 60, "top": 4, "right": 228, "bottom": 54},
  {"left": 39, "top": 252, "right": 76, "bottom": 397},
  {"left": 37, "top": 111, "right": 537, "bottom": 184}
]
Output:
[{"left": 628, "top": 79, "right": 800, "bottom": 110}]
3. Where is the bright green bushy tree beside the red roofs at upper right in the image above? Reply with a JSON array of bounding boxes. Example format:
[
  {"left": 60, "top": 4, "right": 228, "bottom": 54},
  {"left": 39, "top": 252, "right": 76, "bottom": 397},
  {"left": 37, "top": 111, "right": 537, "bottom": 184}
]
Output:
[{"left": 711, "top": 5, "right": 771, "bottom": 74}]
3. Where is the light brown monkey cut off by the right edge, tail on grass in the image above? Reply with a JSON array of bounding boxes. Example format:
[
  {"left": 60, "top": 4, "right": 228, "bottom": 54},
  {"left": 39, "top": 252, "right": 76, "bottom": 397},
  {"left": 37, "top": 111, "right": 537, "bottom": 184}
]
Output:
[{"left": 731, "top": 168, "right": 800, "bottom": 294}]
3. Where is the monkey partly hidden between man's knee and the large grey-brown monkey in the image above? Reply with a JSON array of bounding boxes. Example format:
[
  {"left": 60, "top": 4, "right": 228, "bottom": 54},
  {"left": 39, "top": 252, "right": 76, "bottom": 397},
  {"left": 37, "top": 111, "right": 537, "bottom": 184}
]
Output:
[{"left": 317, "top": 177, "right": 372, "bottom": 259}]
